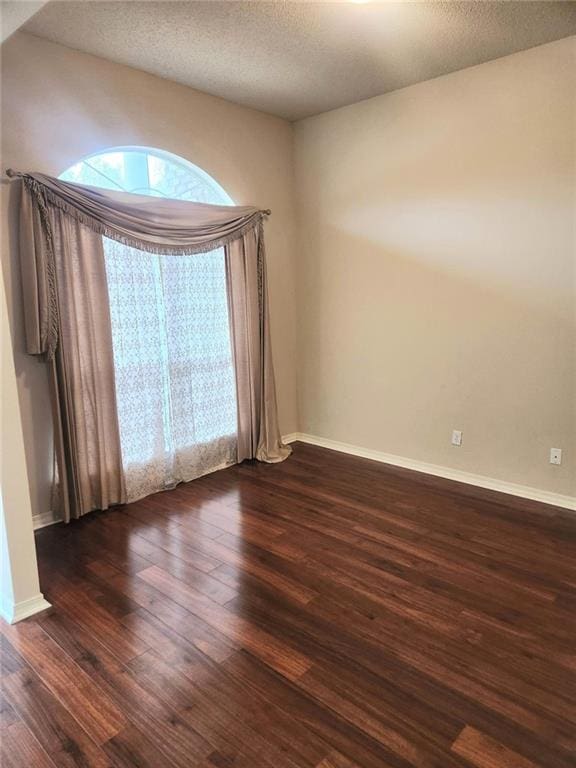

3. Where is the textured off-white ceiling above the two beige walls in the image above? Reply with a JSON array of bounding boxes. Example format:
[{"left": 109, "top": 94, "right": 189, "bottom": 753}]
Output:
[{"left": 24, "top": 0, "right": 576, "bottom": 120}]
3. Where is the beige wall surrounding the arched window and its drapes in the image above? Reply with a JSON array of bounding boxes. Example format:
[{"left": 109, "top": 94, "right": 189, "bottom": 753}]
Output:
[{"left": 2, "top": 33, "right": 297, "bottom": 514}]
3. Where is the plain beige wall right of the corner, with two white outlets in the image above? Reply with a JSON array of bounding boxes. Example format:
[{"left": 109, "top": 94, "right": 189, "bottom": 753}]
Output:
[{"left": 296, "top": 38, "right": 576, "bottom": 495}]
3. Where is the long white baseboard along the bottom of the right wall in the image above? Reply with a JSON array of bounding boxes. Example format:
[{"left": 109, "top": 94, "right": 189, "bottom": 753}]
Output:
[{"left": 282, "top": 432, "right": 576, "bottom": 510}]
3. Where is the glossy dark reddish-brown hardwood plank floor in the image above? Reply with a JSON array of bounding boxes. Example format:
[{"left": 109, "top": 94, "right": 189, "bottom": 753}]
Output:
[{"left": 0, "top": 444, "right": 576, "bottom": 768}]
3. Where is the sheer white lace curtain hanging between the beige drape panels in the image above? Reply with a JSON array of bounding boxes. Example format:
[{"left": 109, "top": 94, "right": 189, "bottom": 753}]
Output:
[{"left": 104, "top": 238, "right": 237, "bottom": 501}]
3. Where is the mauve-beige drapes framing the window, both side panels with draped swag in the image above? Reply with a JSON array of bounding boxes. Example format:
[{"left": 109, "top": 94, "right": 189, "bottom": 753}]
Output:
[{"left": 19, "top": 173, "right": 290, "bottom": 521}]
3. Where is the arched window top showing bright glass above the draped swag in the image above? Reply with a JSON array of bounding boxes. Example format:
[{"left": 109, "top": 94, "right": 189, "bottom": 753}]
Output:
[{"left": 60, "top": 147, "right": 234, "bottom": 205}]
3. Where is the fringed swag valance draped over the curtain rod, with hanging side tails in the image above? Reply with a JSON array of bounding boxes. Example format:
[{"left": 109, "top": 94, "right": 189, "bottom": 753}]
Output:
[{"left": 9, "top": 171, "right": 270, "bottom": 357}]
